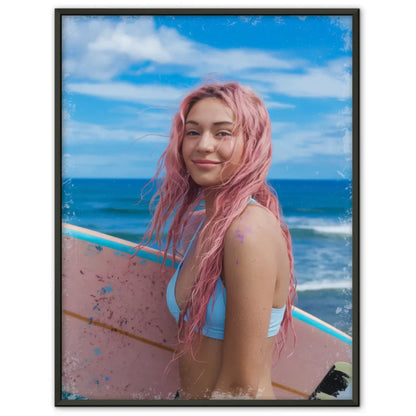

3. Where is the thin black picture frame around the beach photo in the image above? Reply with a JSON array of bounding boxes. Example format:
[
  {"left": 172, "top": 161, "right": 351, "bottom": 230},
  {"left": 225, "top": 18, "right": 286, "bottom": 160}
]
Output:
[{"left": 55, "top": 8, "right": 360, "bottom": 407}]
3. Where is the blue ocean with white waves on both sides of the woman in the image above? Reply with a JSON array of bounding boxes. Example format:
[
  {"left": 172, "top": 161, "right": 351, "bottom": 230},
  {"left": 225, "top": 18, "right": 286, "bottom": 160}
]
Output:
[{"left": 62, "top": 178, "right": 352, "bottom": 335}]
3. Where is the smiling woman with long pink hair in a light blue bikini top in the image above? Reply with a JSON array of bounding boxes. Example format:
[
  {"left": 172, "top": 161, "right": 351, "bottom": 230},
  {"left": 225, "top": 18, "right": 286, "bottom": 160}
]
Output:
[{"left": 140, "top": 82, "right": 295, "bottom": 399}]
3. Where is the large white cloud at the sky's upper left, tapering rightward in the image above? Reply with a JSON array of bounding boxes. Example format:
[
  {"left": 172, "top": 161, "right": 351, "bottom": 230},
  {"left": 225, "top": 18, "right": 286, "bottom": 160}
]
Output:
[{"left": 63, "top": 16, "right": 300, "bottom": 81}]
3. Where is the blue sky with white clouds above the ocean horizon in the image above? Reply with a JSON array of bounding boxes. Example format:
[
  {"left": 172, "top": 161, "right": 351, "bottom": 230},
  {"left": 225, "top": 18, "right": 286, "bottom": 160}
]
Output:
[{"left": 62, "top": 15, "right": 352, "bottom": 179}]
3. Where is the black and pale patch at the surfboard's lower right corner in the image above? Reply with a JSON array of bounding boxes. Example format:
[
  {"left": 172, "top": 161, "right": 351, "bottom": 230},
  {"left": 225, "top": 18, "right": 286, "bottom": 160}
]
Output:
[{"left": 309, "top": 362, "right": 352, "bottom": 400}]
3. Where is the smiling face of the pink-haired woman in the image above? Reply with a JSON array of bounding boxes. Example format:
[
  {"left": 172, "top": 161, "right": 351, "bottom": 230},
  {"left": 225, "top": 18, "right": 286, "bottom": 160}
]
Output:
[{"left": 182, "top": 98, "right": 244, "bottom": 186}]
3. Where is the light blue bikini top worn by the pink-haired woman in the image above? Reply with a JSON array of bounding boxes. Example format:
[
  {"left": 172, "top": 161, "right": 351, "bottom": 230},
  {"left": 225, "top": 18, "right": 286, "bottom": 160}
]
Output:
[{"left": 166, "top": 198, "right": 286, "bottom": 339}]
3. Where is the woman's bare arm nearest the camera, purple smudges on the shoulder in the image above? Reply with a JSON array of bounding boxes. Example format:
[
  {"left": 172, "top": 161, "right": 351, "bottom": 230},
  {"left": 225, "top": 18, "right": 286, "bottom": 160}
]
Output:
[{"left": 211, "top": 206, "right": 287, "bottom": 399}]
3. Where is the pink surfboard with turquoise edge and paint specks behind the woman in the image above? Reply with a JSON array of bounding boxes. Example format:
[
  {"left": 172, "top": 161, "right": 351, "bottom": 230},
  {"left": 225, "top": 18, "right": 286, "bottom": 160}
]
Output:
[{"left": 61, "top": 223, "right": 352, "bottom": 400}]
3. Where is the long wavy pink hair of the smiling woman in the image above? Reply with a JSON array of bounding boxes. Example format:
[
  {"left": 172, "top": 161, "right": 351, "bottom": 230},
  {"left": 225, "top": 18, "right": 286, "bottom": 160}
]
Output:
[{"left": 135, "top": 82, "right": 296, "bottom": 359}]
